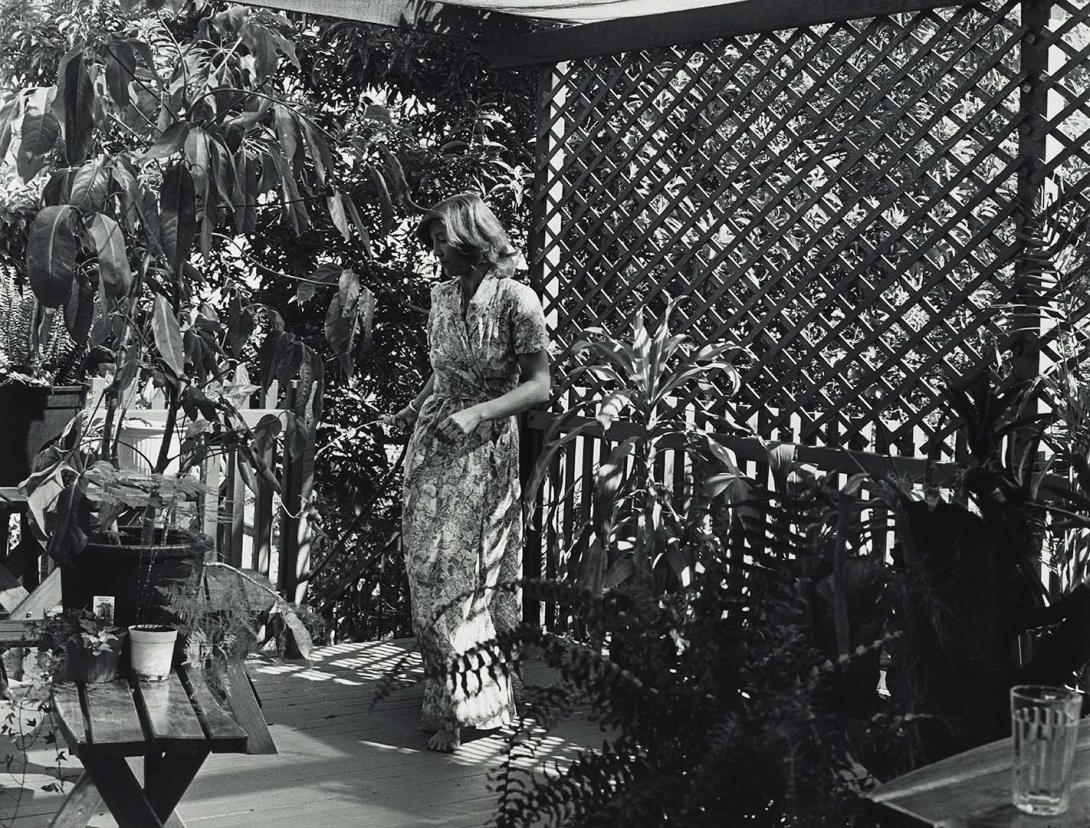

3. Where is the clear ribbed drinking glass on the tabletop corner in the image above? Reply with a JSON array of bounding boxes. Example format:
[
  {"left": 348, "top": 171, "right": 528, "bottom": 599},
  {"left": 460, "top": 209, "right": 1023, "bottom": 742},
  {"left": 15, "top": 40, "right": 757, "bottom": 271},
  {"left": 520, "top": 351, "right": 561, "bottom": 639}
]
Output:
[{"left": 1010, "top": 684, "right": 1082, "bottom": 816}]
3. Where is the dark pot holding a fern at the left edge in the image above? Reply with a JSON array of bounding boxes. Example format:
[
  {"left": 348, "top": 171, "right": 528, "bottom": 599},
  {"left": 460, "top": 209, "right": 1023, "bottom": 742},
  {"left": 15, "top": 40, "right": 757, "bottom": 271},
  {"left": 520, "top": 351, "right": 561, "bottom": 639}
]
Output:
[{"left": 0, "top": 382, "right": 88, "bottom": 486}]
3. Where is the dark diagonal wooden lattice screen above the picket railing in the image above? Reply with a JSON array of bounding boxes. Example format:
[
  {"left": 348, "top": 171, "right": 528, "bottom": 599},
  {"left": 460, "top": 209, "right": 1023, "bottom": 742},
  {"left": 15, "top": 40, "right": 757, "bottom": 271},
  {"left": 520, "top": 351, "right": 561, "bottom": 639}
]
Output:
[{"left": 533, "top": 2, "right": 1090, "bottom": 451}]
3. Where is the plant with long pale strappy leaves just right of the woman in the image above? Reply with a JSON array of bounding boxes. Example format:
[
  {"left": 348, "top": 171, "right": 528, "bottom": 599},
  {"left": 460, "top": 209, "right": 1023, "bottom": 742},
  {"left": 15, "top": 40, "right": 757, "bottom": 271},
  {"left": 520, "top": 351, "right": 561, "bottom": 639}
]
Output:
[{"left": 526, "top": 299, "right": 739, "bottom": 592}]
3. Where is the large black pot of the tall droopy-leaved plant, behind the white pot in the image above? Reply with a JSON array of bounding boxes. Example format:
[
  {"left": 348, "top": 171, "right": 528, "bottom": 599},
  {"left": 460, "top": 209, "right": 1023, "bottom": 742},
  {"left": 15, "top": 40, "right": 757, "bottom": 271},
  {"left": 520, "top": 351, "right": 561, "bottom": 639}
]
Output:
[{"left": 61, "top": 528, "right": 211, "bottom": 626}]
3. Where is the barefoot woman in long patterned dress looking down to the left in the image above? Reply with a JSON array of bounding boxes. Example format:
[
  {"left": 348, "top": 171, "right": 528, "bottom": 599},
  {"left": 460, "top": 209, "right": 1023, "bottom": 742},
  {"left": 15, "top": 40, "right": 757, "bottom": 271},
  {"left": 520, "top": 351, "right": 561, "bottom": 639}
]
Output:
[{"left": 390, "top": 194, "right": 549, "bottom": 752}]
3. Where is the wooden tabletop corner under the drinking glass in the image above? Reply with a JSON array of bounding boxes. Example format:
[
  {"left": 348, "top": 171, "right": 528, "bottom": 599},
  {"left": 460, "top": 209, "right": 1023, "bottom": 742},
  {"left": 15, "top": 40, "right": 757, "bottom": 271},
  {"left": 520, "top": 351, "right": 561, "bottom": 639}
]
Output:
[{"left": 869, "top": 719, "right": 1090, "bottom": 828}]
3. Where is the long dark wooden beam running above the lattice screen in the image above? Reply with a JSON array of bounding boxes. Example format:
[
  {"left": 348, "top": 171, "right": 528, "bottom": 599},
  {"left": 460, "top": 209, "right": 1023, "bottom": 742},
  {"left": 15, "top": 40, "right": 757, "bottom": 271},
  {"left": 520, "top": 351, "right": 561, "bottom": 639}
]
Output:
[{"left": 483, "top": 0, "right": 985, "bottom": 69}]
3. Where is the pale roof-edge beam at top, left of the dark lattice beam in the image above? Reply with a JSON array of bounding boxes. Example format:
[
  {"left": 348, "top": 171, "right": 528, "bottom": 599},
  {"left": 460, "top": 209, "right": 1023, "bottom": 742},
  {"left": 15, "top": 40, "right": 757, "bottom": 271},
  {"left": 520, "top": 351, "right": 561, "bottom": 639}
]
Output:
[{"left": 240, "top": 0, "right": 532, "bottom": 42}]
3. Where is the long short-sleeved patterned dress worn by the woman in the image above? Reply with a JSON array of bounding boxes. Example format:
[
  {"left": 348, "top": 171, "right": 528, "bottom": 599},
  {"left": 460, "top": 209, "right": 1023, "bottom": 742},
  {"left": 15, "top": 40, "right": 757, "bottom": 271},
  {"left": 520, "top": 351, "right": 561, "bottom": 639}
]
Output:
[{"left": 402, "top": 272, "right": 548, "bottom": 729}]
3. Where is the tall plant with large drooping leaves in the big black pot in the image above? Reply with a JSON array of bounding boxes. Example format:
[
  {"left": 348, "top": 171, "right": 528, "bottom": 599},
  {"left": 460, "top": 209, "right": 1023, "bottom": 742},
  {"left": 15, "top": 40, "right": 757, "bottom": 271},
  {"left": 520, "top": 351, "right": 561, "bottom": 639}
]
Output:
[{"left": 0, "top": 0, "right": 383, "bottom": 556}]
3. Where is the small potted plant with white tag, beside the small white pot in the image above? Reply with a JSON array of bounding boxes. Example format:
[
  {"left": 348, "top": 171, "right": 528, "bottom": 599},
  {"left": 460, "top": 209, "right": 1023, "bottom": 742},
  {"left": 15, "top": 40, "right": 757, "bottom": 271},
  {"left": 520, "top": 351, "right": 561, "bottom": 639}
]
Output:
[{"left": 41, "top": 610, "right": 125, "bottom": 684}]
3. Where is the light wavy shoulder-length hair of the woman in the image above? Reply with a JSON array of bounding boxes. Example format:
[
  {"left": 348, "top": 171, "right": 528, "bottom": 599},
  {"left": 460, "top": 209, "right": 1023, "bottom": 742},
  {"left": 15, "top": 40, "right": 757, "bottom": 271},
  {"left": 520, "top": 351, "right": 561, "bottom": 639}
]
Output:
[{"left": 416, "top": 193, "right": 520, "bottom": 276}]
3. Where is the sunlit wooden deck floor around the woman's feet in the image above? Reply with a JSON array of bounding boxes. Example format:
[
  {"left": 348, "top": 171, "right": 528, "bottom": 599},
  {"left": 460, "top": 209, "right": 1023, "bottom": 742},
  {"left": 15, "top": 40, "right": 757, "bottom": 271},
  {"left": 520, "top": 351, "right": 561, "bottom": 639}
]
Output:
[{"left": 0, "top": 641, "right": 601, "bottom": 828}]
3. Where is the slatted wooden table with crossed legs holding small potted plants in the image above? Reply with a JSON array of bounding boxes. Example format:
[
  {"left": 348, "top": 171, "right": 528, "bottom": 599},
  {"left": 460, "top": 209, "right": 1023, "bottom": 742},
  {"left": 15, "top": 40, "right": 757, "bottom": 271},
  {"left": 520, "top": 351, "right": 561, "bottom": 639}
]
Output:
[{"left": 51, "top": 665, "right": 261, "bottom": 828}]
